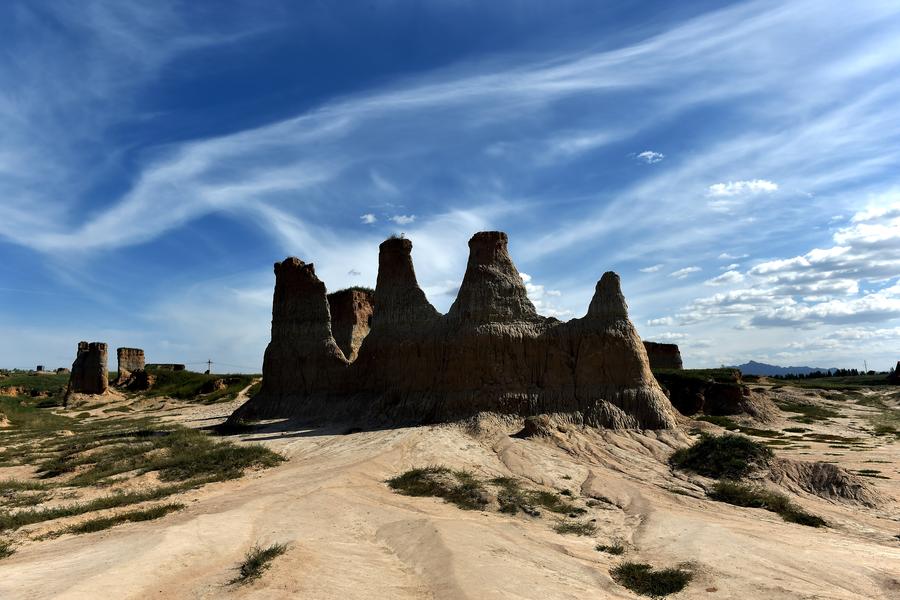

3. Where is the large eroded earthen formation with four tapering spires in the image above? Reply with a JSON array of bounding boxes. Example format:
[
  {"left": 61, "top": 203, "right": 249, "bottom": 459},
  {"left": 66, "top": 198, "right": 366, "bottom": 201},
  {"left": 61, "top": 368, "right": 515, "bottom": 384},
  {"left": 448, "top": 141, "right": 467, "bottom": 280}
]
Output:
[{"left": 232, "top": 231, "right": 676, "bottom": 429}]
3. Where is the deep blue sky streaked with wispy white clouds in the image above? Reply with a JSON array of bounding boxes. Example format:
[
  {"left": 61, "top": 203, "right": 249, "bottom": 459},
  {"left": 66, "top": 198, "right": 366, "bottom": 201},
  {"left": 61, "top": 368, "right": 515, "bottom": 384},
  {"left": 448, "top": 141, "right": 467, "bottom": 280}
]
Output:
[{"left": 0, "top": 0, "right": 900, "bottom": 371}]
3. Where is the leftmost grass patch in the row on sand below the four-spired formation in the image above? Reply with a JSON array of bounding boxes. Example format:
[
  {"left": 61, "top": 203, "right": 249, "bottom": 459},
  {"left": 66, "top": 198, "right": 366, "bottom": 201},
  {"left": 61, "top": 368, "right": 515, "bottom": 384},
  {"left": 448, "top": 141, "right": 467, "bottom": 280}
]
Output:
[{"left": 387, "top": 465, "right": 487, "bottom": 510}]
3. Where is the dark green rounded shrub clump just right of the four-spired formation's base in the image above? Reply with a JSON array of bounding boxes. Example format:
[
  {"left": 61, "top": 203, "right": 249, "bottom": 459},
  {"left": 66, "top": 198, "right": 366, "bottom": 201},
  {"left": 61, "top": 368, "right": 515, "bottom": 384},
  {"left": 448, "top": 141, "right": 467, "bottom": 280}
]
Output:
[{"left": 669, "top": 435, "right": 772, "bottom": 479}]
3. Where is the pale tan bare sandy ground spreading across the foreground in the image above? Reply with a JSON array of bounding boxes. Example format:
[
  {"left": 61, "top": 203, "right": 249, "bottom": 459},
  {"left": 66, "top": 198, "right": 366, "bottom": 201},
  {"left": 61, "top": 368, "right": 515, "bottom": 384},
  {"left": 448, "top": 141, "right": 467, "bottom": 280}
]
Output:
[{"left": 0, "top": 390, "right": 900, "bottom": 600}]
